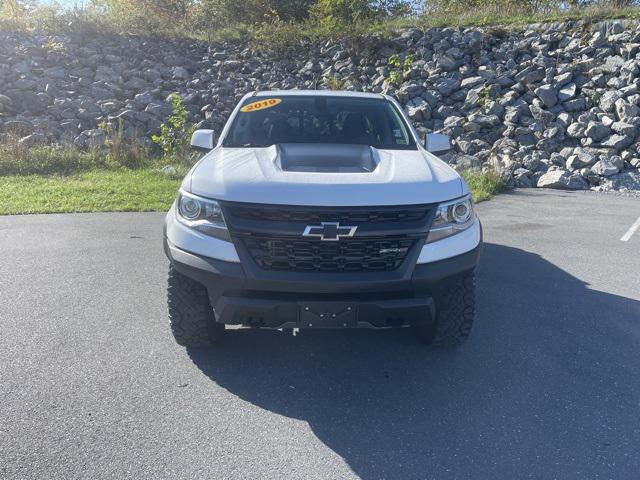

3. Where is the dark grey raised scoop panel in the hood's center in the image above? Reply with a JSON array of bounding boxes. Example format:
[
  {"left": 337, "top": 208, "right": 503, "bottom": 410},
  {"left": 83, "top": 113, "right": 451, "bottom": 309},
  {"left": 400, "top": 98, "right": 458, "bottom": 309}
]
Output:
[{"left": 276, "top": 143, "right": 380, "bottom": 173}]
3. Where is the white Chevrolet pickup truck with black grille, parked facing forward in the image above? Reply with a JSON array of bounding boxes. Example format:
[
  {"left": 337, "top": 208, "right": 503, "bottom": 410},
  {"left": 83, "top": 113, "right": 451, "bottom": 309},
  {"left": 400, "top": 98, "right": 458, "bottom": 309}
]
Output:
[{"left": 164, "top": 90, "right": 482, "bottom": 347}]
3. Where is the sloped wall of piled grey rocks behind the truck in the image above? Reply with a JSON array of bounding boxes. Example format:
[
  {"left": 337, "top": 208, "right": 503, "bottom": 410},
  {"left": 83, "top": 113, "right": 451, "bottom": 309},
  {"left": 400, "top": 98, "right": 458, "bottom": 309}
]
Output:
[{"left": 0, "top": 21, "right": 640, "bottom": 190}]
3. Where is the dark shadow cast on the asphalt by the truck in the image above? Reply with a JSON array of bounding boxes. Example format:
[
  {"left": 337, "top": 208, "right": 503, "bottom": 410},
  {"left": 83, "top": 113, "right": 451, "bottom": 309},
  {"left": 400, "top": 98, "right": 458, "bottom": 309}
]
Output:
[{"left": 189, "top": 244, "right": 640, "bottom": 479}]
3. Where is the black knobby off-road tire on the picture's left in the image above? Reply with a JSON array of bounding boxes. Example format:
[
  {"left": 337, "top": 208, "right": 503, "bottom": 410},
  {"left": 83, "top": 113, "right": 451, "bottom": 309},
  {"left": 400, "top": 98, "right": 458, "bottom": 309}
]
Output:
[{"left": 167, "top": 266, "right": 224, "bottom": 347}]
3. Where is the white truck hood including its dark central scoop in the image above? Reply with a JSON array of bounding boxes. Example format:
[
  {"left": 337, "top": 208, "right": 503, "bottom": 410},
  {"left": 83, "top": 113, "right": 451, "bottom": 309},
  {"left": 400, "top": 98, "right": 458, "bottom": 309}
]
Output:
[{"left": 182, "top": 144, "right": 467, "bottom": 206}]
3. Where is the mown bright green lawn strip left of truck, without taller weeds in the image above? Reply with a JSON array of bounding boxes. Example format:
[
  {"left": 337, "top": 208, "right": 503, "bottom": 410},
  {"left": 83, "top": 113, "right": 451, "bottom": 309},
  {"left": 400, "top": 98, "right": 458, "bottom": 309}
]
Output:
[{"left": 0, "top": 169, "right": 180, "bottom": 215}]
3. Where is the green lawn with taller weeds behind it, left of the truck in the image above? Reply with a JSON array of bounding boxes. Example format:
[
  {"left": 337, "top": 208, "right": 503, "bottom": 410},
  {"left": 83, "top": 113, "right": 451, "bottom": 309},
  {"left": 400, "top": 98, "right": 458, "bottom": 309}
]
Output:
[{"left": 0, "top": 138, "right": 195, "bottom": 215}]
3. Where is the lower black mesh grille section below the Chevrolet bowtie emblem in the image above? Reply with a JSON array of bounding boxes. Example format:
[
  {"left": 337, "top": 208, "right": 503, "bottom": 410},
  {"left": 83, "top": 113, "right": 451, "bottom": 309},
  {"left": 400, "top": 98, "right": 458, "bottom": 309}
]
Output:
[{"left": 241, "top": 236, "right": 417, "bottom": 272}]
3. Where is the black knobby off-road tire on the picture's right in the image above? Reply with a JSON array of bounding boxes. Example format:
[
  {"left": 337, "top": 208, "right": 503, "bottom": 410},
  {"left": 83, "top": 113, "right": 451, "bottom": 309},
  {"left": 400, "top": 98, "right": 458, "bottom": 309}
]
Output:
[{"left": 416, "top": 271, "right": 476, "bottom": 348}]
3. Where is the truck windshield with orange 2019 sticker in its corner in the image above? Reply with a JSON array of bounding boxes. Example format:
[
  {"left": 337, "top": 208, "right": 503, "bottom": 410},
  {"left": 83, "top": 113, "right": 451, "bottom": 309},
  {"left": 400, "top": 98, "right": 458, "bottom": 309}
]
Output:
[{"left": 222, "top": 96, "right": 416, "bottom": 150}]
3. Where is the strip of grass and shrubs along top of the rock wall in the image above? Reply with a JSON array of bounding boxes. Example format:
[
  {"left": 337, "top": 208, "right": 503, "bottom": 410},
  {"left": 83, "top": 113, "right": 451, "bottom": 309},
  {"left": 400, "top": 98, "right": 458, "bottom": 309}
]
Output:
[{"left": 0, "top": 0, "right": 640, "bottom": 42}]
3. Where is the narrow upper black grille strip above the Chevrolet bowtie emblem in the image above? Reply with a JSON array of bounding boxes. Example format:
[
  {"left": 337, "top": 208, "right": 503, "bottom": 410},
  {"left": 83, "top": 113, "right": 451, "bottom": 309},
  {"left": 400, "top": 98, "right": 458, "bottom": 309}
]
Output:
[{"left": 227, "top": 205, "right": 429, "bottom": 225}]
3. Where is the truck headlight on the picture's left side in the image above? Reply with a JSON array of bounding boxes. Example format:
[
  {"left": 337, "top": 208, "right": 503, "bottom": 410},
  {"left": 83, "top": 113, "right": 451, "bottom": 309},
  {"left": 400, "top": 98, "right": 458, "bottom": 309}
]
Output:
[{"left": 176, "top": 190, "right": 231, "bottom": 241}]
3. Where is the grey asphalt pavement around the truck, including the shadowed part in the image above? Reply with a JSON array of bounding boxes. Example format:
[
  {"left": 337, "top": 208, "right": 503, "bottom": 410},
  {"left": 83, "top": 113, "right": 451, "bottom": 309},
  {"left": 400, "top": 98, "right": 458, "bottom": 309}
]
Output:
[{"left": 0, "top": 190, "right": 640, "bottom": 480}]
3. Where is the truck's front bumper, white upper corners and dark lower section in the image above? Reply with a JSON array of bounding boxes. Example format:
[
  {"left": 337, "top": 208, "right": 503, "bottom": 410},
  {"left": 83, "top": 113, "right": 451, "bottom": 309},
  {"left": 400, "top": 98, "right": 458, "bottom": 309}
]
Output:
[{"left": 164, "top": 237, "right": 482, "bottom": 328}]
